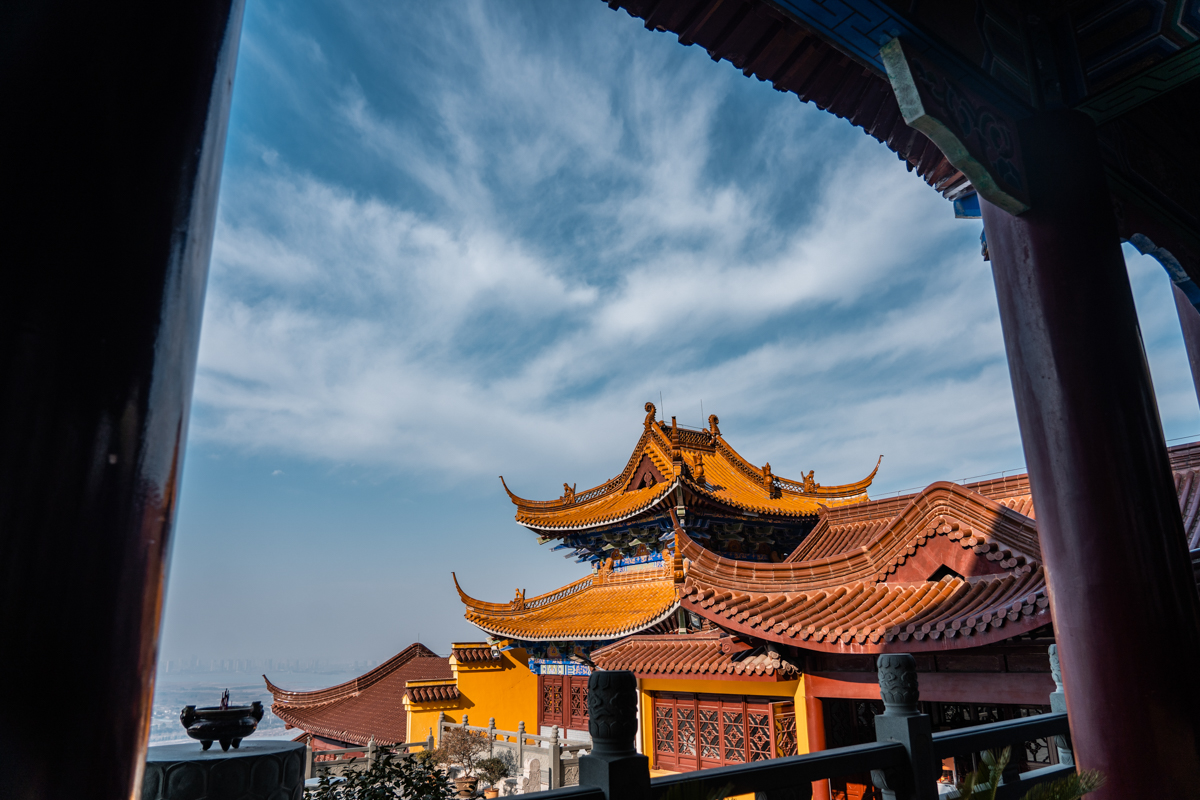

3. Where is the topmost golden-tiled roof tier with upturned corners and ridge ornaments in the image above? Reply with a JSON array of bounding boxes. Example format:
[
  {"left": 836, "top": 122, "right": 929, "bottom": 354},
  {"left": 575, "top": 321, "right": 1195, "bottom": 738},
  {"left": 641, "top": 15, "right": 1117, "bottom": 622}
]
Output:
[{"left": 500, "top": 403, "right": 882, "bottom": 531}]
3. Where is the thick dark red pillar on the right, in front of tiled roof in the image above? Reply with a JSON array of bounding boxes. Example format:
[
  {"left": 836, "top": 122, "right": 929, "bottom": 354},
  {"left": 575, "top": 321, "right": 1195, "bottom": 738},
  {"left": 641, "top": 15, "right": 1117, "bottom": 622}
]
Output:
[{"left": 983, "top": 112, "right": 1200, "bottom": 800}]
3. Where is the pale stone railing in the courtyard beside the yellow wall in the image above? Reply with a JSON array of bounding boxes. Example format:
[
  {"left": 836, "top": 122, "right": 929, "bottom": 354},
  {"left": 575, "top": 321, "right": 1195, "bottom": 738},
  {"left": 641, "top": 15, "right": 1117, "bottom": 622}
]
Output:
[{"left": 437, "top": 712, "right": 592, "bottom": 794}]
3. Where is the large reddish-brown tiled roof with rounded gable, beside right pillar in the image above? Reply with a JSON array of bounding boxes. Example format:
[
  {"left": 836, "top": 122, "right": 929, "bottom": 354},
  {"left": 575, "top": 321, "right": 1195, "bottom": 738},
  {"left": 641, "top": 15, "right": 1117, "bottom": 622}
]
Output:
[{"left": 680, "top": 482, "right": 1050, "bottom": 652}]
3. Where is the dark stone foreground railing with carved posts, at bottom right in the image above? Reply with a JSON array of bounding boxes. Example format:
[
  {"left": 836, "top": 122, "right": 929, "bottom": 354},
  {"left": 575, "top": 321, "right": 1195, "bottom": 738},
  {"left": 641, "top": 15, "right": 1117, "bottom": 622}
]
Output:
[{"left": 520, "top": 648, "right": 1075, "bottom": 800}]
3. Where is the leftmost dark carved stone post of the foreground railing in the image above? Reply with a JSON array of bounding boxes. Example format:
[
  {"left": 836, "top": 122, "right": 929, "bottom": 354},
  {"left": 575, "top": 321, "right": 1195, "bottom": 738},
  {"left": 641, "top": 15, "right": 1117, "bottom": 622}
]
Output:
[{"left": 580, "top": 670, "right": 650, "bottom": 800}]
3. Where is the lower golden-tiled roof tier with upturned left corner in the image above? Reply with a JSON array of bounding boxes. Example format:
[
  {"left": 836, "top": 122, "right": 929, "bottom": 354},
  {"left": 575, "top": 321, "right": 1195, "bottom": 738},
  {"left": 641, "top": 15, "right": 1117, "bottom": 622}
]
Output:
[{"left": 451, "top": 561, "right": 679, "bottom": 642}]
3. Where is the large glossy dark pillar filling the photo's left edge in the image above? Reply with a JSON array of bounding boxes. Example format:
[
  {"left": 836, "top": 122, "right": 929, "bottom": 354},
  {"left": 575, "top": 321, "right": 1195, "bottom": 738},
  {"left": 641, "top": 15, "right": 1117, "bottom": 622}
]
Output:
[{"left": 0, "top": 0, "right": 241, "bottom": 800}]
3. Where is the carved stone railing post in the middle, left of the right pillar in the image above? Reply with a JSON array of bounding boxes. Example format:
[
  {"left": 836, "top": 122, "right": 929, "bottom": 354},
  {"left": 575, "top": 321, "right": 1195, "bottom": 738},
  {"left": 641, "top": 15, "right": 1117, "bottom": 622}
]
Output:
[{"left": 871, "top": 652, "right": 937, "bottom": 800}]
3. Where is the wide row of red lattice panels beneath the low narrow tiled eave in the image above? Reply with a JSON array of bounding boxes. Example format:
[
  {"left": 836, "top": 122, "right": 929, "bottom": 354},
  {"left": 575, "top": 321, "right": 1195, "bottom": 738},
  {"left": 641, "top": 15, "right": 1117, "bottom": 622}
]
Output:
[{"left": 654, "top": 692, "right": 796, "bottom": 772}]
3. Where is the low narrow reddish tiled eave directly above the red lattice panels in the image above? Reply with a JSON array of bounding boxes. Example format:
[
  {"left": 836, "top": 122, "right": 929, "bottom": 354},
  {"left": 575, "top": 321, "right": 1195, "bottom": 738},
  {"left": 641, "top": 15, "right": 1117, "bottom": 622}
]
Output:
[{"left": 592, "top": 631, "right": 799, "bottom": 680}]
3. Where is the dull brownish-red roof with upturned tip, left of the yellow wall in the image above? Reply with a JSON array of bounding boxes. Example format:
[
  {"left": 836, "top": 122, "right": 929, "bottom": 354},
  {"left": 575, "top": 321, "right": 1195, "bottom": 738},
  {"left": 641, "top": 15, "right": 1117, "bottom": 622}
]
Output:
[{"left": 263, "top": 644, "right": 452, "bottom": 745}]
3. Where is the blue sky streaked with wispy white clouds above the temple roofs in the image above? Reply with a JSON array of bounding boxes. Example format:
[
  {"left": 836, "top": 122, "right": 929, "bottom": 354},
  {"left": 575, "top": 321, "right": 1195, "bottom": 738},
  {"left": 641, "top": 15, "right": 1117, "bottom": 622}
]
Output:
[{"left": 154, "top": 0, "right": 1200, "bottom": 676}]
